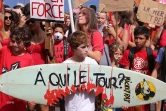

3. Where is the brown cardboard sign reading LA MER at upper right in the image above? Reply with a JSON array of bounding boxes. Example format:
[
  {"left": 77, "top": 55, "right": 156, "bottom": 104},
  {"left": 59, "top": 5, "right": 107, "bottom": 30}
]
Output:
[{"left": 137, "top": 0, "right": 166, "bottom": 26}]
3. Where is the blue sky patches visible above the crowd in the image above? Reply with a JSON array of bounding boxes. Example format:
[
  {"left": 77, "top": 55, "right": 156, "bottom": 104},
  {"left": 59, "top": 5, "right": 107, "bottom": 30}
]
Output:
[{"left": 4, "top": 0, "right": 99, "bottom": 12}]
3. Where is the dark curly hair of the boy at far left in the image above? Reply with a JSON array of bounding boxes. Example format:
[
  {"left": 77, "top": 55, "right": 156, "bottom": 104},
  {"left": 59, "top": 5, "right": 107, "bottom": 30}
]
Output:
[{"left": 10, "top": 27, "right": 32, "bottom": 47}]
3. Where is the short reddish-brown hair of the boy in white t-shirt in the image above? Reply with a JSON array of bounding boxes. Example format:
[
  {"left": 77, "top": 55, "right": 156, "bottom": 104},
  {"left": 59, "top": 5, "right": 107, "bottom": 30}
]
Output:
[{"left": 68, "top": 31, "right": 89, "bottom": 49}]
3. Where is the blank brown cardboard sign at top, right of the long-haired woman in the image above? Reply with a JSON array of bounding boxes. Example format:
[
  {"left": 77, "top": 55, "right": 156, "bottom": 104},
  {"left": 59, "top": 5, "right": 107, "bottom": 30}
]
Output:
[{"left": 99, "top": 0, "right": 134, "bottom": 12}]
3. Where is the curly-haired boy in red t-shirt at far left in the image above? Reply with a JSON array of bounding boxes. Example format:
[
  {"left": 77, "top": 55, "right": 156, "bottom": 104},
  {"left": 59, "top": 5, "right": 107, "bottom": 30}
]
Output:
[{"left": 0, "top": 27, "right": 34, "bottom": 111}]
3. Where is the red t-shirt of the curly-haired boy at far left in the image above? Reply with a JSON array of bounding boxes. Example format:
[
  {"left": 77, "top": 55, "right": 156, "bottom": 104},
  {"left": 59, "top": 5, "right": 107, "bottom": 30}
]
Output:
[{"left": 0, "top": 46, "right": 34, "bottom": 111}]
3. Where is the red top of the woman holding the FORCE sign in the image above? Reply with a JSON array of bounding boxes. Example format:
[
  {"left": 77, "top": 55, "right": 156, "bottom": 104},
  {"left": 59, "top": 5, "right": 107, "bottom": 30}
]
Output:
[{"left": 27, "top": 42, "right": 46, "bottom": 65}]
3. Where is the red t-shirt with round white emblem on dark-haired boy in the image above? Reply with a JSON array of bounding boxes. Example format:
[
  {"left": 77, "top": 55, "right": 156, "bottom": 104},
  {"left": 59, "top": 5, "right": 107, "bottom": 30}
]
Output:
[{"left": 120, "top": 49, "right": 157, "bottom": 76}]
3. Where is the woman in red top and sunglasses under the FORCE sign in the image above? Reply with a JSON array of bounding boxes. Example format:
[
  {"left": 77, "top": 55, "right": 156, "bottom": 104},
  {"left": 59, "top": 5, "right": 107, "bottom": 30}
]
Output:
[{"left": 24, "top": 4, "right": 49, "bottom": 111}]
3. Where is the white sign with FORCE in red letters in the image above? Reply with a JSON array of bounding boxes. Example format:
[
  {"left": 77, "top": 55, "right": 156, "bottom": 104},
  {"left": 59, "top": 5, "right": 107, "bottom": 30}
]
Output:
[{"left": 30, "top": 0, "right": 64, "bottom": 21}]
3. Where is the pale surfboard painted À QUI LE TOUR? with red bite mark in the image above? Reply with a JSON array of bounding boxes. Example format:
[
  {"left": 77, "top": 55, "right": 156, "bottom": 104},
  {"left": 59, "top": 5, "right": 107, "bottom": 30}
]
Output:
[{"left": 0, "top": 64, "right": 166, "bottom": 108}]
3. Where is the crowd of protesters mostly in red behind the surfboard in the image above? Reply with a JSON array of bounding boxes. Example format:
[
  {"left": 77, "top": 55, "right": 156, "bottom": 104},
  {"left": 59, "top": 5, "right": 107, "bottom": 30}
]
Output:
[{"left": 0, "top": 0, "right": 166, "bottom": 111}]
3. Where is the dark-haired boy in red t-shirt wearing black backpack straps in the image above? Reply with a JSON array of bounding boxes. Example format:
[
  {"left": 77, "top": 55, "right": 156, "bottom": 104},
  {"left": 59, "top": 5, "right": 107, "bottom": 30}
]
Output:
[{"left": 120, "top": 26, "right": 157, "bottom": 111}]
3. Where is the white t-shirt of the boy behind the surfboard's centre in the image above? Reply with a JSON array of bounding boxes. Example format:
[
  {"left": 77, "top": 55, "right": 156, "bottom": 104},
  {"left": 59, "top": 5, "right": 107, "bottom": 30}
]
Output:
[{"left": 63, "top": 57, "right": 97, "bottom": 111}]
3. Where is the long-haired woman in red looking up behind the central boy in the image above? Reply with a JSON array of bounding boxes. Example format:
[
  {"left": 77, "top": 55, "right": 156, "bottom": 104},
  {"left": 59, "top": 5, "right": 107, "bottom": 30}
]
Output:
[{"left": 76, "top": 7, "right": 104, "bottom": 63}]
